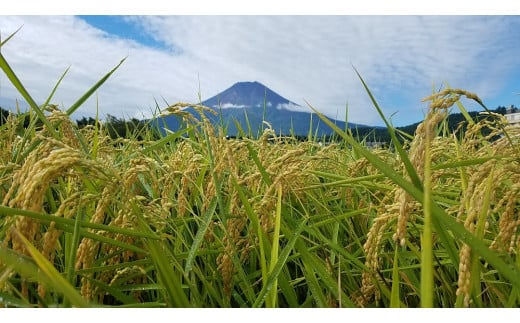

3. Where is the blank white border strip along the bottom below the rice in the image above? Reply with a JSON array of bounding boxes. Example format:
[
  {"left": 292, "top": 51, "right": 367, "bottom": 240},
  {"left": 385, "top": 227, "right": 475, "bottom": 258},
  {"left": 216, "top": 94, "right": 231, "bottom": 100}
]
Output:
[{"left": 0, "top": 308, "right": 519, "bottom": 323}]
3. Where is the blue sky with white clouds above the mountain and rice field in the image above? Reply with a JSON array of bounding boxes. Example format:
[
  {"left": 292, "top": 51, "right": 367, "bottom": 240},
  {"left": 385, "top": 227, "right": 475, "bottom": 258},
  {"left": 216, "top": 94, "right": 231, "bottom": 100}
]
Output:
[{"left": 0, "top": 3, "right": 520, "bottom": 126}]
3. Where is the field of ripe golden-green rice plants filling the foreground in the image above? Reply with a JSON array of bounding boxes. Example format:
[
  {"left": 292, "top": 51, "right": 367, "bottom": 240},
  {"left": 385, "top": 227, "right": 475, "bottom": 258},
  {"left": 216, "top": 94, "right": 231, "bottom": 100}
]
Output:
[{"left": 0, "top": 39, "right": 520, "bottom": 308}]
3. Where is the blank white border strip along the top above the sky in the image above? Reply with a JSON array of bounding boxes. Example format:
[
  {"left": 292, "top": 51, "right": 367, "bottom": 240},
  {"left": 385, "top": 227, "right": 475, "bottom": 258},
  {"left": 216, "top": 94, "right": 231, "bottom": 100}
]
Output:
[{"left": 0, "top": 0, "right": 520, "bottom": 15}]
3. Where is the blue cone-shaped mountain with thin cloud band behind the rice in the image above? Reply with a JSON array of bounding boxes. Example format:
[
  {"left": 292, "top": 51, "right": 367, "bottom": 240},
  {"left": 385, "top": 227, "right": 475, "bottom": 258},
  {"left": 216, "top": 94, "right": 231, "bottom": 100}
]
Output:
[{"left": 159, "top": 82, "right": 361, "bottom": 136}]
